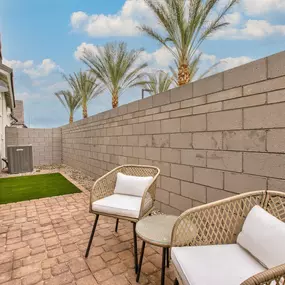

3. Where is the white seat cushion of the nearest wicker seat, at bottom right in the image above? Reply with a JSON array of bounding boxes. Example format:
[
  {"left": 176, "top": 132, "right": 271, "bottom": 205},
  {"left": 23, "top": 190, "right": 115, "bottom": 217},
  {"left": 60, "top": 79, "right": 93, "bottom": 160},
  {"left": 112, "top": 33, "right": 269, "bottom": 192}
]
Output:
[{"left": 171, "top": 244, "right": 265, "bottom": 285}]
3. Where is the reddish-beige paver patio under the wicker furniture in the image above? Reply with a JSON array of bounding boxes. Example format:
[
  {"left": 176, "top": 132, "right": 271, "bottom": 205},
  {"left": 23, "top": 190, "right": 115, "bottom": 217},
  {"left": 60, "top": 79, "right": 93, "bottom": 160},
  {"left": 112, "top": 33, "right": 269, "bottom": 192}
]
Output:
[{"left": 0, "top": 189, "right": 174, "bottom": 285}]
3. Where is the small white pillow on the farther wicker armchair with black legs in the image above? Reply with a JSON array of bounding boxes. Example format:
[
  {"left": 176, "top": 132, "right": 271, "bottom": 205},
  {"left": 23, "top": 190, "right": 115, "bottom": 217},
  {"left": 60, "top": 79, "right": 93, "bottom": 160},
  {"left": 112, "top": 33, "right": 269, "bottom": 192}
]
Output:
[{"left": 114, "top": 172, "right": 153, "bottom": 197}]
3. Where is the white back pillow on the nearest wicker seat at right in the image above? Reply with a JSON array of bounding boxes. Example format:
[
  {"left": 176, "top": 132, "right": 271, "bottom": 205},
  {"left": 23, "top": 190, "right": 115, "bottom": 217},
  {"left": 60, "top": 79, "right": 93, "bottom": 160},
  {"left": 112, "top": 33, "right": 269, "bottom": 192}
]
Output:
[{"left": 237, "top": 206, "right": 285, "bottom": 268}]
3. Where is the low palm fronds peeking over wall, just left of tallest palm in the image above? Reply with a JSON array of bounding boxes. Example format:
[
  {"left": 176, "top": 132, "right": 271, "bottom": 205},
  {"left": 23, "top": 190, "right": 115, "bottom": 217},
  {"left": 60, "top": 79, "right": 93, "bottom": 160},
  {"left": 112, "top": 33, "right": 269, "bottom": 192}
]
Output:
[{"left": 145, "top": 70, "right": 173, "bottom": 95}]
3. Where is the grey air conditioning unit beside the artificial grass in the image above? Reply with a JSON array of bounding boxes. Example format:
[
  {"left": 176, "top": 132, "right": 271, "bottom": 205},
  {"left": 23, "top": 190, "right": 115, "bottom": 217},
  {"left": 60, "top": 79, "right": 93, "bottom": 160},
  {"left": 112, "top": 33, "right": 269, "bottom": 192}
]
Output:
[{"left": 7, "top": 145, "right": 34, "bottom": 173}]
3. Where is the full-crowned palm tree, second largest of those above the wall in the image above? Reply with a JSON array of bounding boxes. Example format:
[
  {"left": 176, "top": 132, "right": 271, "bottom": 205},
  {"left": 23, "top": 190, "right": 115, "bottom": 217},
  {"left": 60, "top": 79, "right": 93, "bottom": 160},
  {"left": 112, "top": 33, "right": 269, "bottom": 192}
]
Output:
[{"left": 82, "top": 42, "right": 147, "bottom": 108}]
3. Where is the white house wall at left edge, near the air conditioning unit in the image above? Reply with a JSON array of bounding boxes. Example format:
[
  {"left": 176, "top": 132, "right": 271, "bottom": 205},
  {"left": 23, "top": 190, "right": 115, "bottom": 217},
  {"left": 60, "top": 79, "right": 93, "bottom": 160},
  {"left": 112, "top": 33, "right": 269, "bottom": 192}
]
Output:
[{"left": 0, "top": 93, "right": 11, "bottom": 166}]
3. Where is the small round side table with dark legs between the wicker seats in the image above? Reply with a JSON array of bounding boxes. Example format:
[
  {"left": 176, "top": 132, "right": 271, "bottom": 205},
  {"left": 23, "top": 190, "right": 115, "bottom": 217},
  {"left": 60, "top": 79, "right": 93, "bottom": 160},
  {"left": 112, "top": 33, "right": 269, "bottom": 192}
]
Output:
[{"left": 136, "top": 215, "right": 178, "bottom": 285}]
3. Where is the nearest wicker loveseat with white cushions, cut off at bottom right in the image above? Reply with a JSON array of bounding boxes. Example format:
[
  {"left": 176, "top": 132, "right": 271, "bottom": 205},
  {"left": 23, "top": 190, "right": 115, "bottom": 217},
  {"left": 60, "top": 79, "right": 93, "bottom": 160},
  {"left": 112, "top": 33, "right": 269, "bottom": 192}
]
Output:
[{"left": 171, "top": 191, "right": 285, "bottom": 285}]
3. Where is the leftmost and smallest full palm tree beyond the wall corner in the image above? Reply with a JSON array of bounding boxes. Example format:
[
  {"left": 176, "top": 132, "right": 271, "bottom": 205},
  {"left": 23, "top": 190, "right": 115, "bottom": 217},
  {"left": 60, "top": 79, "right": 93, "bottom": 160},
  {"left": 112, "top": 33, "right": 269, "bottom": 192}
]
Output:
[{"left": 55, "top": 90, "right": 81, "bottom": 124}]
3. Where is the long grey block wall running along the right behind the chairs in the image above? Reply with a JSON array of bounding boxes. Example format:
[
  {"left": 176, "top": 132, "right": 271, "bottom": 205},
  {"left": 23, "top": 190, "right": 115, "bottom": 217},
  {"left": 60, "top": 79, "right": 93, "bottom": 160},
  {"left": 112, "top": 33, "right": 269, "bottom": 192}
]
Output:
[{"left": 62, "top": 52, "right": 285, "bottom": 214}]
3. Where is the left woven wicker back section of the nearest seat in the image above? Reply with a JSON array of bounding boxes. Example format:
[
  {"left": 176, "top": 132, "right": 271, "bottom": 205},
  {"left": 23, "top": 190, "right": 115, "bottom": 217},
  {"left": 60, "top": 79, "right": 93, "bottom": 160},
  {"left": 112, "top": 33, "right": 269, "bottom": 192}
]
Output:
[{"left": 172, "top": 191, "right": 266, "bottom": 246}]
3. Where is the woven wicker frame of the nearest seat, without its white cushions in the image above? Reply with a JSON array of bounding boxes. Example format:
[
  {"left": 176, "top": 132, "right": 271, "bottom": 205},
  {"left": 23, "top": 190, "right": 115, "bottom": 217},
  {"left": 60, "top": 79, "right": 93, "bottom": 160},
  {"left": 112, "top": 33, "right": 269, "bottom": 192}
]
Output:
[{"left": 172, "top": 191, "right": 285, "bottom": 285}]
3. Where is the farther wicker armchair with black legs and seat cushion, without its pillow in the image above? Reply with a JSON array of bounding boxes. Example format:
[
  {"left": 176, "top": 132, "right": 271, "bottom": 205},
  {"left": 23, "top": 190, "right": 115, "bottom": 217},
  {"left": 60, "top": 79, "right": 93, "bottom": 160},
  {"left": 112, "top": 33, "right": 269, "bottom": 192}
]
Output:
[{"left": 85, "top": 165, "right": 160, "bottom": 271}]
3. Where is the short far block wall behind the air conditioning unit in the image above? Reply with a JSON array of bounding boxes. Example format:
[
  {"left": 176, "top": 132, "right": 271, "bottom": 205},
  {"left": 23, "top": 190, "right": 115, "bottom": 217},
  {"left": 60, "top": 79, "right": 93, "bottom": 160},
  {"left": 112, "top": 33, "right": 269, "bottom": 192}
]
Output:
[{"left": 6, "top": 127, "right": 62, "bottom": 166}]
